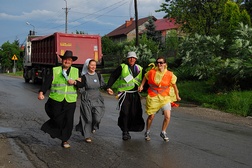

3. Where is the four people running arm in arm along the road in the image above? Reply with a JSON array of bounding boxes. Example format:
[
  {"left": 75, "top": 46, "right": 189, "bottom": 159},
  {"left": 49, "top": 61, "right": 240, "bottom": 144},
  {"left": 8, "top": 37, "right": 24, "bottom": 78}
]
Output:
[{"left": 38, "top": 50, "right": 181, "bottom": 148}]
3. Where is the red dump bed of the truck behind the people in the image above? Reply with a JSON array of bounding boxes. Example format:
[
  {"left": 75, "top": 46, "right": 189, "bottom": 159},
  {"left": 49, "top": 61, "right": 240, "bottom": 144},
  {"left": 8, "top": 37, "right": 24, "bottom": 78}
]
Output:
[{"left": 31, "top": 32, "right": 102, "bottom": 67}]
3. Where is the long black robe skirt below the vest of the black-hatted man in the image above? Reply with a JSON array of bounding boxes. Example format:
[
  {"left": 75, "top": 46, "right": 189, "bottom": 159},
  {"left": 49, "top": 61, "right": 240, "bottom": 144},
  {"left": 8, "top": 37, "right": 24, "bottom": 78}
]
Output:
[{"left": 41, "top": 98, "right": 76, "bottom": 141}]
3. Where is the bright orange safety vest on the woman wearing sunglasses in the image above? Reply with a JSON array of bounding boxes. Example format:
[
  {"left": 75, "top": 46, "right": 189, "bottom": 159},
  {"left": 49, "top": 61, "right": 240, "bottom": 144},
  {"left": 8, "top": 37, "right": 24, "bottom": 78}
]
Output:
[{"left": 148, "top": 69, "right": 172, "bottom": 97}]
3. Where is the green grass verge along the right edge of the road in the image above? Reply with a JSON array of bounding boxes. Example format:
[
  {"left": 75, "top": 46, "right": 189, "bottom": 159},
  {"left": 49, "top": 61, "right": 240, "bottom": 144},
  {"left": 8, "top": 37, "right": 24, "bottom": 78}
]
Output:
[{"left": 178, "top": 81, "right": 252, "bottom": 116}]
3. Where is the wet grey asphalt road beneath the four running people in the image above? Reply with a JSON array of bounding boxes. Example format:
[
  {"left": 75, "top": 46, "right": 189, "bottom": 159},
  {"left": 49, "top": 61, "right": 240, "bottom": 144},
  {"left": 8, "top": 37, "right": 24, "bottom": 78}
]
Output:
[{"left": 0, "top": 74, "right": 252, "bottom": 168}]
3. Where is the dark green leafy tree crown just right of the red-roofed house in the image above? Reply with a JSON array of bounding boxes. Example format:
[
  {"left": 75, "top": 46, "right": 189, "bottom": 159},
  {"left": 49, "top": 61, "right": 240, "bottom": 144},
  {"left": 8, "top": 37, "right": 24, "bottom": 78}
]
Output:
[{"left": 157, "top": 0, "right": 227, "bottom": 35}]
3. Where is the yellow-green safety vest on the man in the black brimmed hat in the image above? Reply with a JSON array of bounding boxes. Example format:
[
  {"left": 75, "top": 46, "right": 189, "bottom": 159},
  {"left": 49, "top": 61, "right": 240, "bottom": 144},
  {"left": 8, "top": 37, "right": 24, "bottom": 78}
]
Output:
[{"left": 49, "top": 66, "right": 79, "bottom": 103}]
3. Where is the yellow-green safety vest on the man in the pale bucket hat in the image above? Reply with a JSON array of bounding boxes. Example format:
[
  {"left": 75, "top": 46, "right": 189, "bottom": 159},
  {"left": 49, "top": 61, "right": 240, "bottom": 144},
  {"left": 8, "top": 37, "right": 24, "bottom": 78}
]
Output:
[{"left": 118, "top": 64, "right": 143, "bottom": 91}]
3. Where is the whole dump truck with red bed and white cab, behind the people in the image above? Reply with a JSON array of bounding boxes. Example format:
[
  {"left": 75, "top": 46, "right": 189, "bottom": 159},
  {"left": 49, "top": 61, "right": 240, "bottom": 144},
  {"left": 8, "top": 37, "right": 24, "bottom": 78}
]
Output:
[{"left": 23, "top": 32, "right": 103, "bottom": 83}]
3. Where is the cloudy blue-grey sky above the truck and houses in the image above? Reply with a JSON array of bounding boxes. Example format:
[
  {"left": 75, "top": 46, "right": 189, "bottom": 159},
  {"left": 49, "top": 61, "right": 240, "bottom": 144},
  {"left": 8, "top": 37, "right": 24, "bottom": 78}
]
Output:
[{"left": 0, "top": 0, "right": 165, "bottom": 46}]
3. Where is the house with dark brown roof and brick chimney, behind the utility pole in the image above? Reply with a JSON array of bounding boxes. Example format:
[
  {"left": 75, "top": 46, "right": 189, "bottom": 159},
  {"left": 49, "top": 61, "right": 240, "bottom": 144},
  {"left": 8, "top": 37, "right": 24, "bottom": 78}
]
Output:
[{"left": 107, "top": 16, "right": 157, "bottom": 42}]
